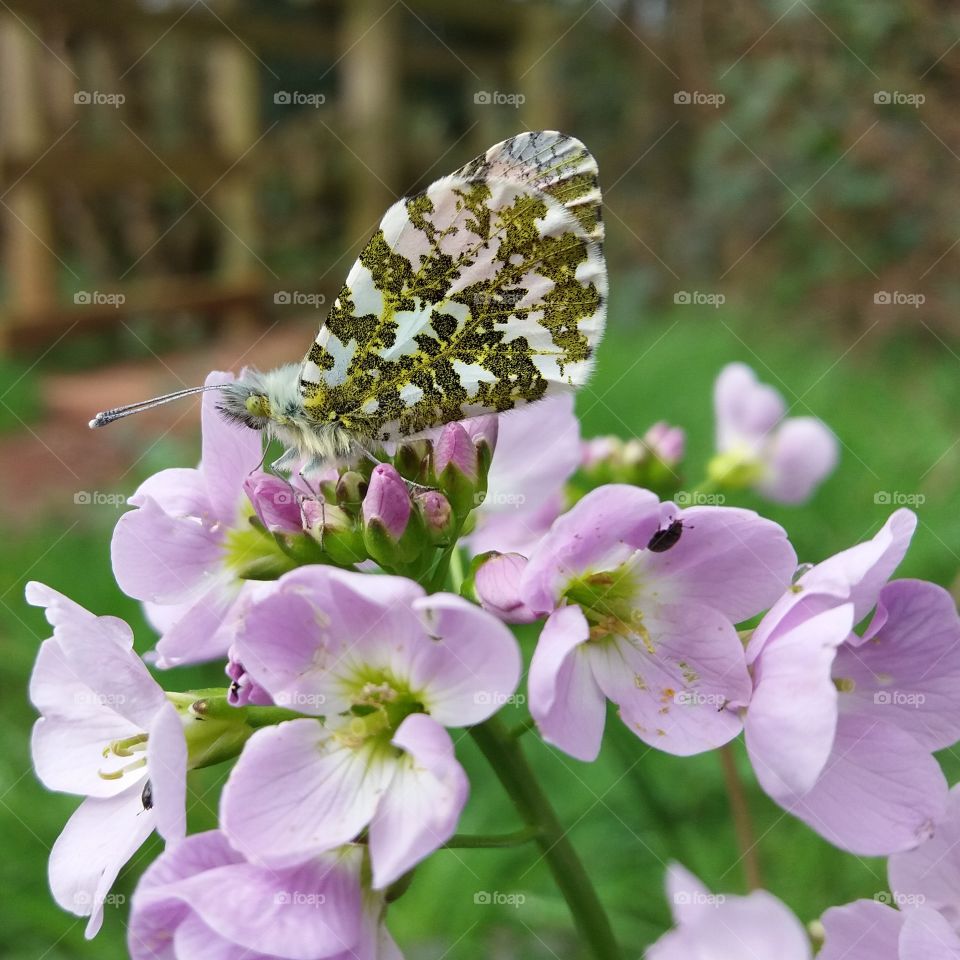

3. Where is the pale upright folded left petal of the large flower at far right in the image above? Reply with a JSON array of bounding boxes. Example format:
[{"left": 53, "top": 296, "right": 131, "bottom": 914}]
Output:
[{"left": 744, "top": 603, "right": 853, "bottom": 803}]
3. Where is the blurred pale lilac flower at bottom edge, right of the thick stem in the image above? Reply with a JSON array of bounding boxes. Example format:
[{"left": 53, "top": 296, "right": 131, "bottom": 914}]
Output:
[{"left": 645, "top": 864, "right": 813, "bottom": 960}]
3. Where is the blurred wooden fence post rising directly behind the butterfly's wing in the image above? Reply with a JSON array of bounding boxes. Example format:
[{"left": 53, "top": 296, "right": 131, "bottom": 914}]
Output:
[{"left": 340, "top": 0, "right": 403, "bottom": 249}]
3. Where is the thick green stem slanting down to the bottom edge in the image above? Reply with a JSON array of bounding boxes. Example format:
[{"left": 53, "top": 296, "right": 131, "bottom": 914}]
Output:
[{"left": 470, "top": 717, "right": 623, "bottom": 960}]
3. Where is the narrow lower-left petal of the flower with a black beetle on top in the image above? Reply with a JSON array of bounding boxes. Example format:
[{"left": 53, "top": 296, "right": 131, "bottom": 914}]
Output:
[{"left": 527, "top": 606, "right": 606, "bottom": 762}]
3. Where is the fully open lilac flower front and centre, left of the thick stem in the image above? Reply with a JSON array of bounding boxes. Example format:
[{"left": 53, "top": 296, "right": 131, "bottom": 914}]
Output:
[{"left": 221, "top": 566, "right": 520, "bottom": 889}]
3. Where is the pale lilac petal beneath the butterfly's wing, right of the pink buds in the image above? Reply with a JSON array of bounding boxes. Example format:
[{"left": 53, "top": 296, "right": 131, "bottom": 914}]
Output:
[{"left": 470, "top": 395, "right": 580, "bottom": 556}]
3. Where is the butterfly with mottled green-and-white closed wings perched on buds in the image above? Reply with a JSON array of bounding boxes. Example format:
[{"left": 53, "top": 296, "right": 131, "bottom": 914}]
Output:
[{"left": 90, "top": 131, "right": 607, "bottom": 468}]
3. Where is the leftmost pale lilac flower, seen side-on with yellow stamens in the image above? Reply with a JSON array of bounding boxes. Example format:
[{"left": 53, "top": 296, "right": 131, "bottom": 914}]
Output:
[{"left": 27, "top": 583, "right": 187, "bottom": 937}]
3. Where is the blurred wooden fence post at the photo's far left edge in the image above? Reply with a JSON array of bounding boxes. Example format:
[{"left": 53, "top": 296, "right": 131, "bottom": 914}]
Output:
[{"left": 0, "top": 16, "right": 57, "bottom": 339}]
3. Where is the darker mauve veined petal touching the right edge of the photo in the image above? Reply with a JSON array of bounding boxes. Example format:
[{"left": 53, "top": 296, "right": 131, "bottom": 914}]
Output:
[{"left": 833, "top": 580, "right": 960, "bottom": 752}]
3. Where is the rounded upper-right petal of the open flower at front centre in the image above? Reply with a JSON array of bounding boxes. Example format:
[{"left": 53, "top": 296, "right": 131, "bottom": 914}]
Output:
[{"left": 409, "top": 593, "right": 523, "bottom": 727}]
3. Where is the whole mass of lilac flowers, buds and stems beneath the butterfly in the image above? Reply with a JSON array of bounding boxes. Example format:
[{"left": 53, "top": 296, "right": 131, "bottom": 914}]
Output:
[{"left": 27, "top": 364, "right": 960, "bottom": 960}]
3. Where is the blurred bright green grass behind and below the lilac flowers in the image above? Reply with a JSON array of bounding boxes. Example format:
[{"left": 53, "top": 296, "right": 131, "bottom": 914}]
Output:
[{"left": 0, "top": 303, "right": 960, "bottom": 960}]
